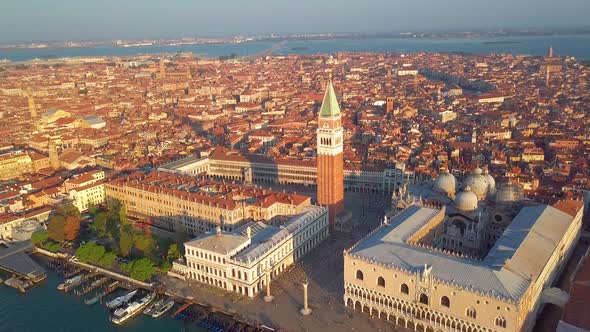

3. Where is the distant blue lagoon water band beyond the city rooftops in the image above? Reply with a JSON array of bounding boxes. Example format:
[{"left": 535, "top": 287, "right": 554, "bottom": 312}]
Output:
[{"left": 0, "top": 35, "right": 590, "bottom": 61}]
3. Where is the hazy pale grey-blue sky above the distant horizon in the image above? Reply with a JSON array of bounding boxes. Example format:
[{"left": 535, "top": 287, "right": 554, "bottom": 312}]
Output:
[{"left": 0, "top": 0, "right": 590, "bottom": 42}]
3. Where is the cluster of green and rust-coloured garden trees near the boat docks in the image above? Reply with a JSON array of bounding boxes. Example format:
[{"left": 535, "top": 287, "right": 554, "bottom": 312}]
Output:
[{"left": 31, "top": 201, "right": 181, "bottom": 281}]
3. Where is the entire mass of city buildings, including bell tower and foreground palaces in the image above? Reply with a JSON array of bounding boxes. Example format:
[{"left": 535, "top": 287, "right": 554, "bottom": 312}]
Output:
[{"left": 0, "top": 49, "right": 590, "bottom": 332}]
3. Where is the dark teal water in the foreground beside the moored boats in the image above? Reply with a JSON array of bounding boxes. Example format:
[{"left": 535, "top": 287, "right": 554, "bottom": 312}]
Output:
[{"left": 0, "top": 258, "right": 202, "bottom": 332}]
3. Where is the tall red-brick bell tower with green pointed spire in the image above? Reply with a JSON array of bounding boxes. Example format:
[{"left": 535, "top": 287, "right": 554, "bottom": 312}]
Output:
[{"left": 317, "top": 79, "right": 344, "bottom": 226}]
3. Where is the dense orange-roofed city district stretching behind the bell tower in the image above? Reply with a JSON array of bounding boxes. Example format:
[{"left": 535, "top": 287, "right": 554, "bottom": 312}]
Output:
[{"left": 0, "top": 53, "right": 588, "bottom": 196}]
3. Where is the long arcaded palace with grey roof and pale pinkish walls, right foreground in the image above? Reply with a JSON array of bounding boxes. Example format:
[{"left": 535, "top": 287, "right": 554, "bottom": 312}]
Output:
[{"left": 344, "top": 201, "right": 582, "bottom": 332}]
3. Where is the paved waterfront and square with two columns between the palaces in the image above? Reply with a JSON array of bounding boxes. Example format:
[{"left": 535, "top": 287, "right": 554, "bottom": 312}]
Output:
[{"left": 159, "top": 233, "right": 403, "bottom": 331}]
